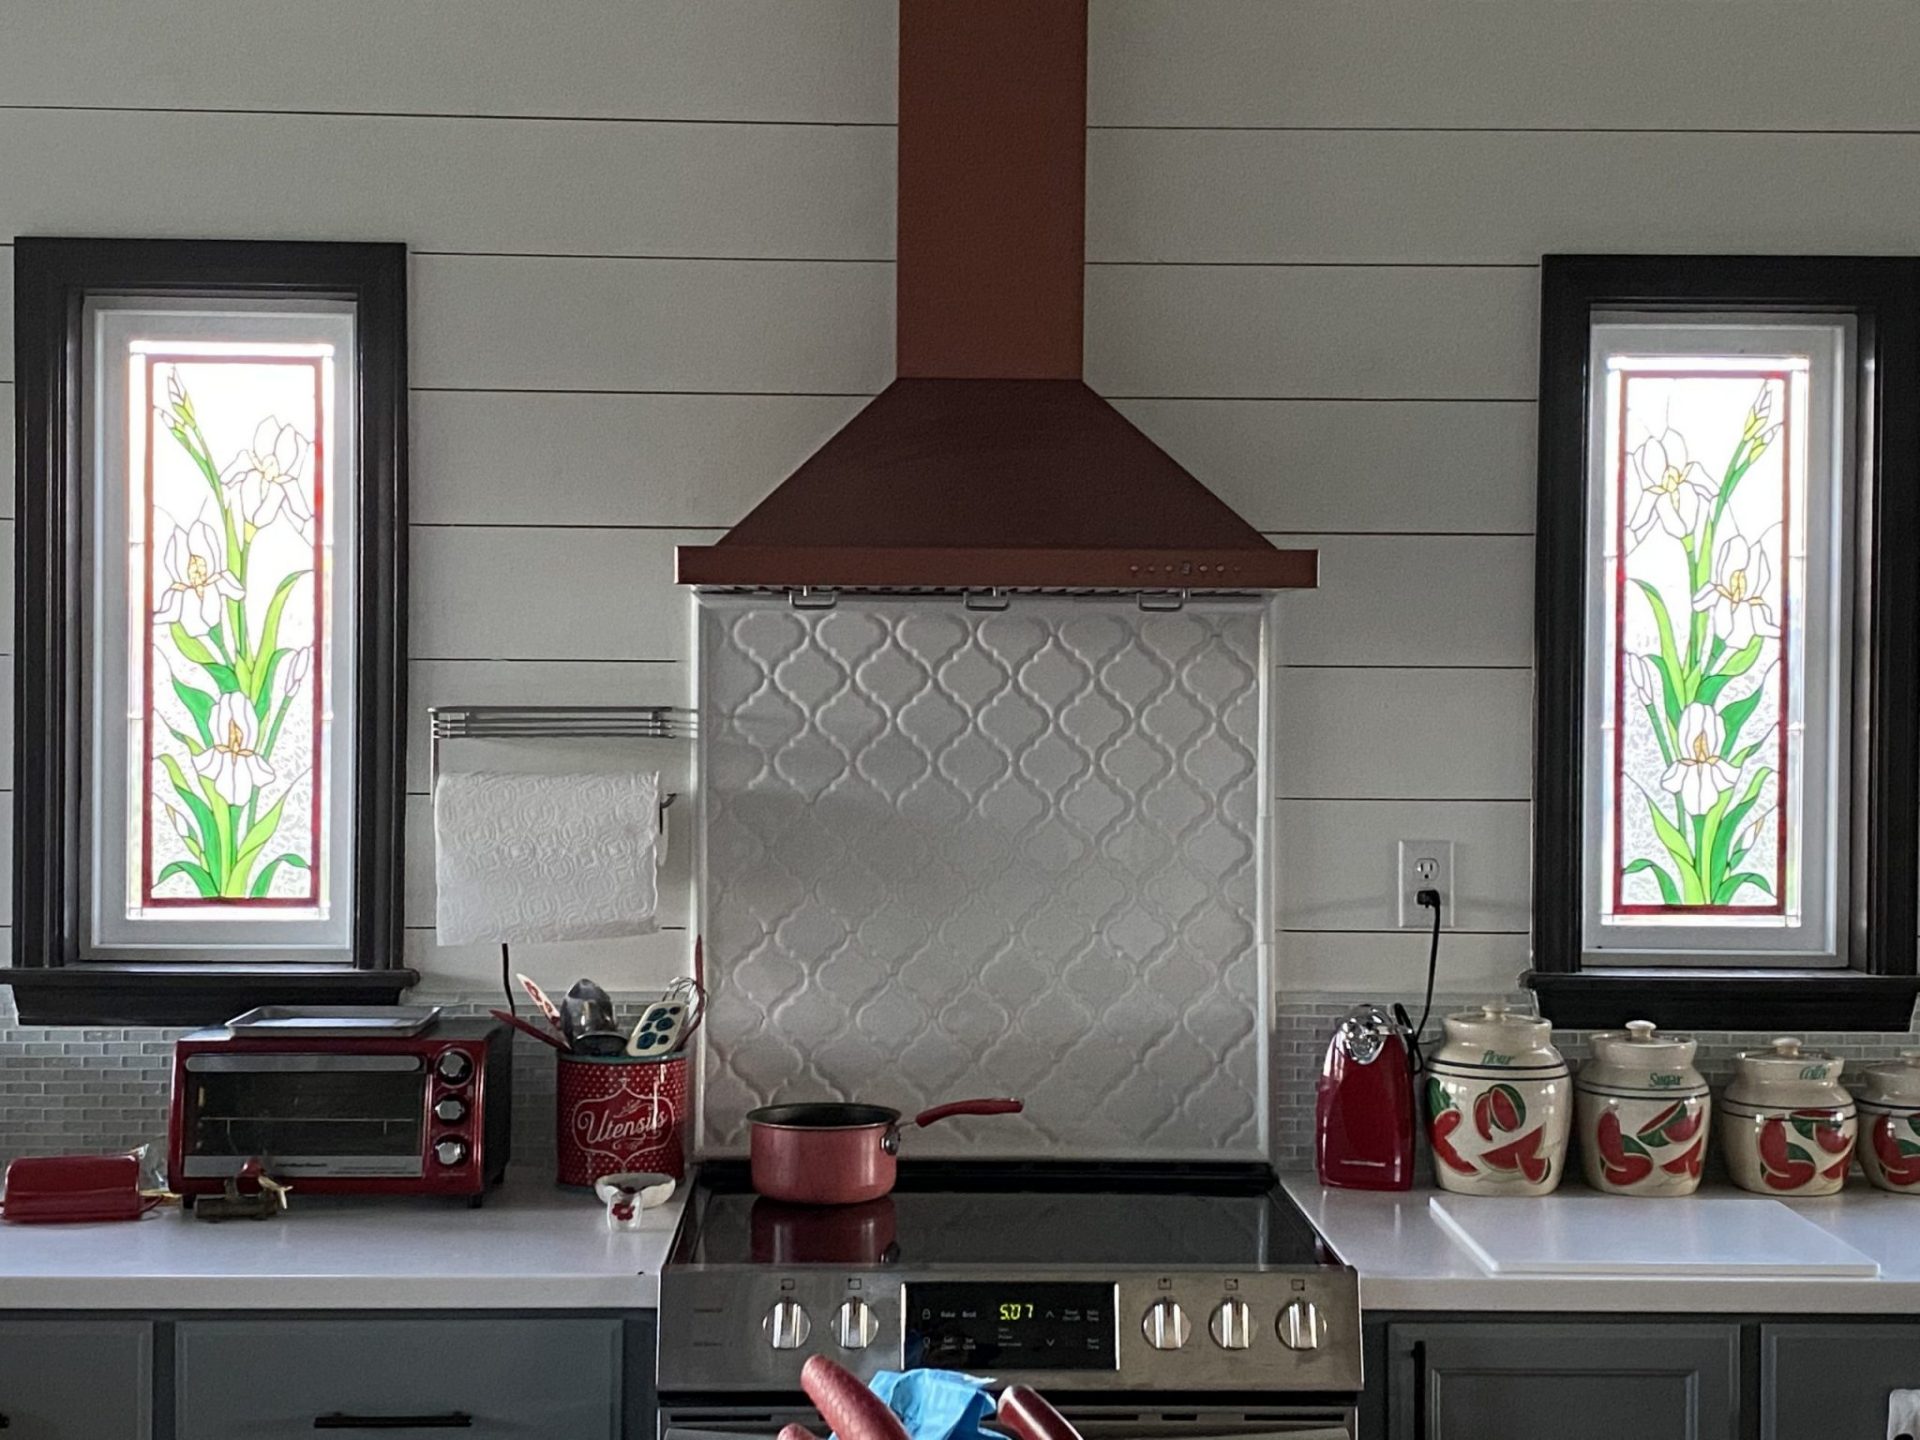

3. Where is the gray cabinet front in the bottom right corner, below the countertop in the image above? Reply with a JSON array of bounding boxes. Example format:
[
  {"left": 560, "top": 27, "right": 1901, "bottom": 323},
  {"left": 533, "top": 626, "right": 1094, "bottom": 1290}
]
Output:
[{"left": 1761, "top": 1321, "right": 1920, "bottom": 1440}]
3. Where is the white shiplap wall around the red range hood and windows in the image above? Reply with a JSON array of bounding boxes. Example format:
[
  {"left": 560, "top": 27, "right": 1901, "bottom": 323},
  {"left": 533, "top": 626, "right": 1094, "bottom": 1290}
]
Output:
[{"left": 0, "top": 0, "right": 1920, "bottom": 993}]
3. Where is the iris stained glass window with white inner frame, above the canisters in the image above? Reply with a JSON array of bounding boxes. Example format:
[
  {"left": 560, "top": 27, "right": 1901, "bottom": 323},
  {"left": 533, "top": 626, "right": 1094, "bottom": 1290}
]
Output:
[{"left": 1588, "top": 321, "right": 1845, "bottom": 962}]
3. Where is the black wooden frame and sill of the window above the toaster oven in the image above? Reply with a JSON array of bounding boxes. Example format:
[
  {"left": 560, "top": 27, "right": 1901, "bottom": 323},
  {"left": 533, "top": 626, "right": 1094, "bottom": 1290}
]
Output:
[{"left": 0, "top": 236, "right": 419, "bottom": 1025}]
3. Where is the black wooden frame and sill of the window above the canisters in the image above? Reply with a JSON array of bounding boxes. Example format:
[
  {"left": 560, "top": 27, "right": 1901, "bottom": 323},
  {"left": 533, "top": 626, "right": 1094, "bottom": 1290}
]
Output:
[{"left": 1526, "top": 255, "right": 1920, "bottom": 1031}]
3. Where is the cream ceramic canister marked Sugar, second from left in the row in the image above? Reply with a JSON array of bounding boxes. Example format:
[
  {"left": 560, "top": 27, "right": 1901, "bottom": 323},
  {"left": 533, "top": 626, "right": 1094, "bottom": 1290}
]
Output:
[{"left": 1574, "top": 1020, "right": 1713, "bottom": 1196}]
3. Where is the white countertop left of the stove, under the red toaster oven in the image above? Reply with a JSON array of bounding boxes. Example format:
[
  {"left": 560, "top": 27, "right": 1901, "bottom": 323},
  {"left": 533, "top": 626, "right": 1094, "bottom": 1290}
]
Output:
[{"left": 0, "top": 1171, "right": 685, "bottom": 1311}]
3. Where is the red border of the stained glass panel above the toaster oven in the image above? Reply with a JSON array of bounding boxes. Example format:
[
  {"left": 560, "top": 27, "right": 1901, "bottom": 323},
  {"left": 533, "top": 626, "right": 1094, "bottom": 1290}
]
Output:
[{"left": 140, "top": 351, "right": 326, "bottom": 910}]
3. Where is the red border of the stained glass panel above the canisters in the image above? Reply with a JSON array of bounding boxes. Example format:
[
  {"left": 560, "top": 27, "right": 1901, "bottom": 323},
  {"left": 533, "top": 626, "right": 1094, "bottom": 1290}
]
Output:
[{"left": 1611, "top": 369, "right": 1793, "bottom": 916}]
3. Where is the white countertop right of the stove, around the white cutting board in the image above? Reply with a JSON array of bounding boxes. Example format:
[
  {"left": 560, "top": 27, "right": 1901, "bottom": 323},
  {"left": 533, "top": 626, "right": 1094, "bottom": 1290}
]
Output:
[{"left": 1284, "top": 1175, "right": 1920, "bottom": 1315}]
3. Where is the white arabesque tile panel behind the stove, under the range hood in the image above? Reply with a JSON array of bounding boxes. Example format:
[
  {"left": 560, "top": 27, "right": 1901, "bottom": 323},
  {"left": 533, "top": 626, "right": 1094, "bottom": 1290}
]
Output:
[{"left": 699, "top": 597, "right": 1271, "bottom": 1158}]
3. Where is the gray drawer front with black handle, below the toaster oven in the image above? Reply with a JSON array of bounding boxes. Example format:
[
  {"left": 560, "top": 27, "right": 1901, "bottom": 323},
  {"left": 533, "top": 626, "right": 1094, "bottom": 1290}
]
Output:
[{"left": 174, "top": 1317, "right": 626, "bottom": 1440}]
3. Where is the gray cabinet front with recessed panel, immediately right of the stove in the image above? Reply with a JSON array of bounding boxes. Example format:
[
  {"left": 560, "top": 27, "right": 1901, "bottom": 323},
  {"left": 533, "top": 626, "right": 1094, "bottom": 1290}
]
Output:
[{"left": 1386, "top": 1321, "right": 1740, "bottom": 1440}]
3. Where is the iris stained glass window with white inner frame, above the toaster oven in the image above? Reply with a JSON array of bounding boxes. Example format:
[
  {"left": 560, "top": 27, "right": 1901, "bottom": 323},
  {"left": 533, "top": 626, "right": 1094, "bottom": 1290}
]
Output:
[{"left": 90, "top": 305, "right": 353, "bottom": 952}]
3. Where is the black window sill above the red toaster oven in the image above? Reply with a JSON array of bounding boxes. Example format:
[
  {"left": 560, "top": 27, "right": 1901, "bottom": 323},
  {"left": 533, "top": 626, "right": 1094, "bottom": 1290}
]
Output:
[{"left": 0, "top": 964, "right": 420, "bottom": 1025}]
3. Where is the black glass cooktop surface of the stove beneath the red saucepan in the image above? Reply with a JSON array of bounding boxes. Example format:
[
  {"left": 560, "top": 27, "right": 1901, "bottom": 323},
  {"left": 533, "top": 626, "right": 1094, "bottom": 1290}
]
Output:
[{"left": 670, "top": 1162, "right": 1338, "bottom": 1271}]
